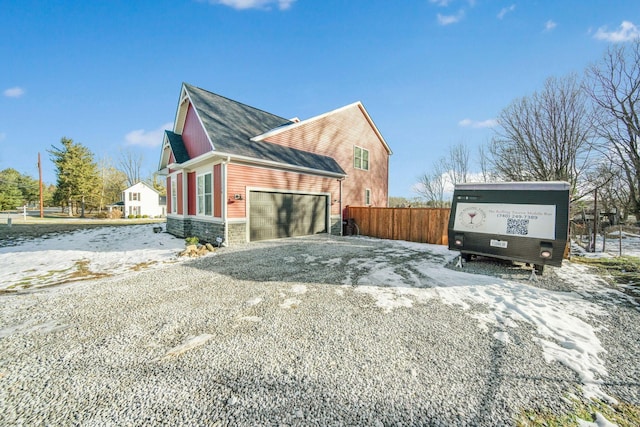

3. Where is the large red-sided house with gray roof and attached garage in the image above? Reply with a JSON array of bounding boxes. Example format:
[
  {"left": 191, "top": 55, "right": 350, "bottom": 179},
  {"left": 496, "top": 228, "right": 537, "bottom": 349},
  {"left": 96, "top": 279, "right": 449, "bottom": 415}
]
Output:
[{"left": 158, "top": 83, "right": 391, "bottom": 244}]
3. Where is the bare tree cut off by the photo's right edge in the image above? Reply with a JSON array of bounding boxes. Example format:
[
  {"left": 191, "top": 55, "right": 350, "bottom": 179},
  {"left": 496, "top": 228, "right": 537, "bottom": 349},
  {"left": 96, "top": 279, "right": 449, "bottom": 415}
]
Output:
[{"left": 585, "top": 39, "right": 640, "bottom": 215}]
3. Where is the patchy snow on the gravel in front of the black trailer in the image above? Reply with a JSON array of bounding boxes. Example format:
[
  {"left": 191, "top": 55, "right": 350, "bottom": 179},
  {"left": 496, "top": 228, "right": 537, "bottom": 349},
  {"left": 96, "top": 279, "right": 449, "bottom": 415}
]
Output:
[{"left": 345, "top": 242, "right": 624, "bottom": 403}]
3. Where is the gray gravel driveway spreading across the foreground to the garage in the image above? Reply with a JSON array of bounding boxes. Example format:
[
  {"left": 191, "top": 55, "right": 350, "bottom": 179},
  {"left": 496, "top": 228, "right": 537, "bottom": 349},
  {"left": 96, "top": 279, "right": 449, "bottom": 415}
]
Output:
[{"left": 0, "top": 236, "right": 640, "bottom": 426}]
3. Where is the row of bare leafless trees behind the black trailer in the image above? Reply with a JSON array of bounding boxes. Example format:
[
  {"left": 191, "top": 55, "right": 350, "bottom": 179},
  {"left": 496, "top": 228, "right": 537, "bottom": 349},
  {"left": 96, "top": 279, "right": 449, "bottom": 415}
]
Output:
[{"left": 415, "top": 39, "right": 640, "bottom": 224}]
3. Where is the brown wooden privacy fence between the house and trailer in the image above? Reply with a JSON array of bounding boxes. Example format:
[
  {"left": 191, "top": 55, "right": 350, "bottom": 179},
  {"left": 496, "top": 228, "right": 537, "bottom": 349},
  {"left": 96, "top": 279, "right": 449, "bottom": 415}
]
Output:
[{"left": 344, "top": 206, "right": 451, "bottom": 245}]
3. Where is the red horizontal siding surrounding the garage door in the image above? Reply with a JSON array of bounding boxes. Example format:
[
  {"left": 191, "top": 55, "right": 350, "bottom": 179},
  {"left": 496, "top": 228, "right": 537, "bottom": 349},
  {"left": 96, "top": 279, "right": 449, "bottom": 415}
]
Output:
[{"left": 227, "top": 164, "right": 340, "bottom": 218}]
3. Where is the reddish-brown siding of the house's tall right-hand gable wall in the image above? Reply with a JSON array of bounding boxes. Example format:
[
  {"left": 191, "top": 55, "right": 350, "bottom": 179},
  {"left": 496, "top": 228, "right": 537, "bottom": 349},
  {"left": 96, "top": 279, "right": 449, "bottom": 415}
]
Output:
[{"left": 266, "top": 105, "right": 389, "bottom": 207}]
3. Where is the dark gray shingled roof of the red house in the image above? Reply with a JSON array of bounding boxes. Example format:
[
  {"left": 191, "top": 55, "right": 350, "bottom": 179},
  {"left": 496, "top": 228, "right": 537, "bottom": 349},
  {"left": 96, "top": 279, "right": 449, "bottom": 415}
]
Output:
[{"left": 182, "top": 83, "right": 345, "bottom": 174}]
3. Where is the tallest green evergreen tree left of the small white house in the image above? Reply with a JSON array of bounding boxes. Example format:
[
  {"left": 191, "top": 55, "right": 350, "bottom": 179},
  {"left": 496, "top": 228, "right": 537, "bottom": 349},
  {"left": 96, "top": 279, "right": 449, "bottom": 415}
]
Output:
[{"left": 48, "top": 137, "right": 100, "bottom": 216}]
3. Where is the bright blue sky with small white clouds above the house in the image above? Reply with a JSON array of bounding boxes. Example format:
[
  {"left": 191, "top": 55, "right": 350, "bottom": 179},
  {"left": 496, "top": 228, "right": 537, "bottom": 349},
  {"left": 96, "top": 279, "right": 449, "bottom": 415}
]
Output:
[{"left": 0, "top": 0, "right": 640, "bottom": 197}]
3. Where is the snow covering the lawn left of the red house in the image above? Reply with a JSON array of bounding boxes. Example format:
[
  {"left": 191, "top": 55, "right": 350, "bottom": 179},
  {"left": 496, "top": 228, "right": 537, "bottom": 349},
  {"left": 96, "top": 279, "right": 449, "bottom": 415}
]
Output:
[{"left": 0, "top": 224, "right": 185, "bottom": 290}]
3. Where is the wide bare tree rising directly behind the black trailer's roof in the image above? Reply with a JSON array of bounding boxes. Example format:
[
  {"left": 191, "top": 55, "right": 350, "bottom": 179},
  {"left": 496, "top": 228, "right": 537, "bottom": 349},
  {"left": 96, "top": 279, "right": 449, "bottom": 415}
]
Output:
[{"left": 489, "top": 75, "right": 594, "bottom": 191}]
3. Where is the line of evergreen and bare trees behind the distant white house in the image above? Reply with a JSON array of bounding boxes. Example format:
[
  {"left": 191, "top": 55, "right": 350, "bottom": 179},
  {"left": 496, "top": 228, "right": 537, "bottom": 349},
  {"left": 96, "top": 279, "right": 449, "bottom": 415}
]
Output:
[{"left": 0, "top": 137, "right": 166, "bottom": 216}]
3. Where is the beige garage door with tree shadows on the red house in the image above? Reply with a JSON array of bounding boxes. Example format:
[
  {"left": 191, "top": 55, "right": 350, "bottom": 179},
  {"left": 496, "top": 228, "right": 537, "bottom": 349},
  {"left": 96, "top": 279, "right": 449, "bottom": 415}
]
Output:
[{"left": 249, "top": 191, "right": 327, "bottom": 241}]
